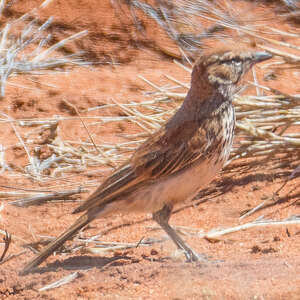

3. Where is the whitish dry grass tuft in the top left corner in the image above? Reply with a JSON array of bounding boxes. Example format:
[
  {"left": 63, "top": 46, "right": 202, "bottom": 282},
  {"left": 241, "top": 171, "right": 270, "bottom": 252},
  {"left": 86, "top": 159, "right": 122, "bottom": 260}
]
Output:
[{"left": 0, "top": 0, "right": 87, "bottom": 97}]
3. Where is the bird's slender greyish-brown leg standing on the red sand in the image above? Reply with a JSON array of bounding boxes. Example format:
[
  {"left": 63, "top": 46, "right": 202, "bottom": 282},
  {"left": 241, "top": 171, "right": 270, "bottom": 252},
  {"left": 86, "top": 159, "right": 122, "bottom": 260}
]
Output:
[{"left": 152, "top": 205, "right": 205, "bottom": 262}]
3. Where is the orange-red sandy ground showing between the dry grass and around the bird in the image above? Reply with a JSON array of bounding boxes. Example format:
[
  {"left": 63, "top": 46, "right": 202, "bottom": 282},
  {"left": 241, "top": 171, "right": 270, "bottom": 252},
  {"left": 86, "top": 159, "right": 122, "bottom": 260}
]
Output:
[{"left": 0, "top": 0, "right": 300, "bottom": 299}]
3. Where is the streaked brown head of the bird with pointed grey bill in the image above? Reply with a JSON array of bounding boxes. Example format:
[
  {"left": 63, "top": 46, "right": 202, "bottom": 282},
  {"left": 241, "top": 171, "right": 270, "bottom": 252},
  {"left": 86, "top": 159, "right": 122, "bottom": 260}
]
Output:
[{"left": 192, "top": 48, "right": 272, "bottom": 94}]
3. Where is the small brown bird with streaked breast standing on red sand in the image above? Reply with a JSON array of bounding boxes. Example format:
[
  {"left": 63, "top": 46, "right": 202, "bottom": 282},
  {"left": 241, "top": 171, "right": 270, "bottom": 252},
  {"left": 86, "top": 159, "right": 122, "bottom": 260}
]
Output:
[{"left": 22, "top": 48, "right": 272, "bottom": 274}]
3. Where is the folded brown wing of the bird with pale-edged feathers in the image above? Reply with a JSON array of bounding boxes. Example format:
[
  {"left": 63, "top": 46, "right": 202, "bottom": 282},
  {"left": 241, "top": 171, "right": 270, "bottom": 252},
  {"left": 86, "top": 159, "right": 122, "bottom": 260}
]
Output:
[{"left": 73, "top": 121, "right": 209, "bottom": 213}]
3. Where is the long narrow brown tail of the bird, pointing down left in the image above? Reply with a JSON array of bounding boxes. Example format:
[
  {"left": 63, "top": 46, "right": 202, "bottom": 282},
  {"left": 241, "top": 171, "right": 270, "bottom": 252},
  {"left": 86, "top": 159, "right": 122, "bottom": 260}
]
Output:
[{"left": 20, "top": 214, "right": 92, "bottom": 275}]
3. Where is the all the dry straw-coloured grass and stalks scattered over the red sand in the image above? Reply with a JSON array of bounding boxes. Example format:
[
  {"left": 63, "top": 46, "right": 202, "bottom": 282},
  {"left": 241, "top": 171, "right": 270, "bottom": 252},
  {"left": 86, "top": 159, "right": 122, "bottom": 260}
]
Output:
[{"left": 0, "top": 0, "right": 300, "bottom": 274}]
